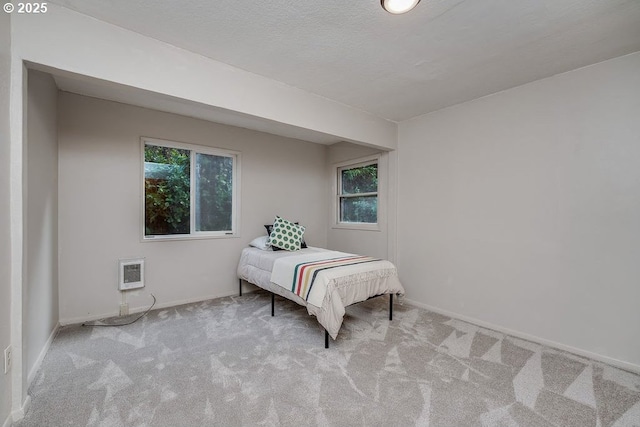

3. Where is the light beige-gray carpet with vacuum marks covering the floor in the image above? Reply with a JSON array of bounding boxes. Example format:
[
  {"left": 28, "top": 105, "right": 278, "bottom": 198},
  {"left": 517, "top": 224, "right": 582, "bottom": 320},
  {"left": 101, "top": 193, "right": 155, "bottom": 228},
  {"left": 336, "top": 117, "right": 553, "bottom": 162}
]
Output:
[{"left": 17, "top": 292, "right": 640, "bottom": 427}]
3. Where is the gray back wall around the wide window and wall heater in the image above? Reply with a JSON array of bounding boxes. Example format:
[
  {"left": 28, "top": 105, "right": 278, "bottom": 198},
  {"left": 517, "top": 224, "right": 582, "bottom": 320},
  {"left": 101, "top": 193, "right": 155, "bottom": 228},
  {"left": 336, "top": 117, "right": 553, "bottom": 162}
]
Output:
[{"left": 58, "top": 93, "right": 327, "bottom": 323}]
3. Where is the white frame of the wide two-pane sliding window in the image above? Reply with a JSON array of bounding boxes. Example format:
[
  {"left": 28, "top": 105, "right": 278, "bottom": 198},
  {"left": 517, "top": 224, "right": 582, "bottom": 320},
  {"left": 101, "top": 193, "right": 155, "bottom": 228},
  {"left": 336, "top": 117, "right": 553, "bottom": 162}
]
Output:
[{"left": 140, "top": 137, "right": 241, "bottom": 242}]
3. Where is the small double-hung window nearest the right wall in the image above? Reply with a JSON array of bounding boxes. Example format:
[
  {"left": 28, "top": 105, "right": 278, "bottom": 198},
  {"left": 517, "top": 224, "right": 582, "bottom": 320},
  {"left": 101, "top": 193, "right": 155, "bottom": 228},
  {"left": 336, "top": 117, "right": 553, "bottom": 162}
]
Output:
[{"left": 337, "top": 159, "right": 378, "bottom": 224}]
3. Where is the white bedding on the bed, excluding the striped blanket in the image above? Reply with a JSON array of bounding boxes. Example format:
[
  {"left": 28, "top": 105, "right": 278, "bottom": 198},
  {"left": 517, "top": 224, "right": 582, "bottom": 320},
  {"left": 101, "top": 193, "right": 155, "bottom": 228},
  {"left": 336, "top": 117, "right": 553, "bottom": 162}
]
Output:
[{"left": 238, "top": 247, "right": 404, "bottom": 339}]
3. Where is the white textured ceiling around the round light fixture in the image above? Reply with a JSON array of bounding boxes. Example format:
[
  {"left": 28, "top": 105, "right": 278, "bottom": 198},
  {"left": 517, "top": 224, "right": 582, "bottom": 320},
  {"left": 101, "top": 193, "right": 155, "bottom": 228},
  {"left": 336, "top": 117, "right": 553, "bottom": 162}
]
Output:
[{"left": 47, "top": 0, "right": 640, "bottom": 121}]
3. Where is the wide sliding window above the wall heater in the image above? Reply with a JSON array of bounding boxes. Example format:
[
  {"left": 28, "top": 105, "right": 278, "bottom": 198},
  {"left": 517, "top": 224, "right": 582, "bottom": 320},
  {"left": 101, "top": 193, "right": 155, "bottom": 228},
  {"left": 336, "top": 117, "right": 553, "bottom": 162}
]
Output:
[{"left": 142, "top": 138, "right": 239, "bottom": 239}]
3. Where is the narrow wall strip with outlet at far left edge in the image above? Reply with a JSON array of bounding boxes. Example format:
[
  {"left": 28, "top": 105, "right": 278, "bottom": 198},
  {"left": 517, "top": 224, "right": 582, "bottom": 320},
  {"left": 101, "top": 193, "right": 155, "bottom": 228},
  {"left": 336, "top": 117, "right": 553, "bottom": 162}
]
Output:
[{"left": 0, "top": 13, "right": 11, "bottom": 423}]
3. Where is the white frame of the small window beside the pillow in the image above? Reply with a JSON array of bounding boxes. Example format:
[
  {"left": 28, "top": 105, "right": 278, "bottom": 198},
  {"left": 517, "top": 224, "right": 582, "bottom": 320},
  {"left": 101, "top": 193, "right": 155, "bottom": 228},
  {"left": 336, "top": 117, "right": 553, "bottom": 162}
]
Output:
[{"left": 331, "top": 154, "right": 386, "bottom": 231}]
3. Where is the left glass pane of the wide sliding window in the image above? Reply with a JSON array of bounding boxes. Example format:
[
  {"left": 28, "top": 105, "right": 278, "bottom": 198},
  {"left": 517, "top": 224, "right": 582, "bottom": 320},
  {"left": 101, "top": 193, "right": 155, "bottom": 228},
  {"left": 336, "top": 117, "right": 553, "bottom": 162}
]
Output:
[{"left": 144, "top": 145, "right": 191, "bottom": 236}]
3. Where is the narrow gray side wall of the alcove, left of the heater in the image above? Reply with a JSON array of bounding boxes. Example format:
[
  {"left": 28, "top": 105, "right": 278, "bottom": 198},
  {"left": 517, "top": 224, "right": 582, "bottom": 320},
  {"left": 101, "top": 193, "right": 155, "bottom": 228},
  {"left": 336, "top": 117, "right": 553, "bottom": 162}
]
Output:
[{"left": 22, "top": 70, "right": 58, "bottom": 382}]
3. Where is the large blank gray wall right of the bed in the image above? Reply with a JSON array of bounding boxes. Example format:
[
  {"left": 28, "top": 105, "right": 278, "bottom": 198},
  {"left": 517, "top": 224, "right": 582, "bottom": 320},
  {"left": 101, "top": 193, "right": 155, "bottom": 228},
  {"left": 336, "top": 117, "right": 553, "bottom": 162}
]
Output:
[{"left": 398, "top": 53, "right": 640, "bottom": 370}]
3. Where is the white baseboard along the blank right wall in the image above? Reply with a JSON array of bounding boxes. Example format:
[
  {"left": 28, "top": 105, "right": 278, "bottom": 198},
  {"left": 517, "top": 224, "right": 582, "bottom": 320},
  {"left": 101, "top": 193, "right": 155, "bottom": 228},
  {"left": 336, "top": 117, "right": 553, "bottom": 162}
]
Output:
[{"left": 403, "top": 298, "right": 640, "bottom": 374}]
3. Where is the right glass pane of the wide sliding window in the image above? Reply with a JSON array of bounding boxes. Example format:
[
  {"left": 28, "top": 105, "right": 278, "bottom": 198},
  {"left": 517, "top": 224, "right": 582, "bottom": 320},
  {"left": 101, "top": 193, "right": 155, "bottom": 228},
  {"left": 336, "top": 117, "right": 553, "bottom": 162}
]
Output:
[{"left": 195, "top": 153, "right": 233, "bottom": 231}]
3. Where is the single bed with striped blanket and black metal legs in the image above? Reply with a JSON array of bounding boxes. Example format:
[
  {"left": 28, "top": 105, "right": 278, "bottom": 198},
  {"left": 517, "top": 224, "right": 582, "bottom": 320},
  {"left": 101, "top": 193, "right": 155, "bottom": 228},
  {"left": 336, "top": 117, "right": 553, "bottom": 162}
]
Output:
[{"left": 238, "top": 247, "right": 404, "bottom": 348}]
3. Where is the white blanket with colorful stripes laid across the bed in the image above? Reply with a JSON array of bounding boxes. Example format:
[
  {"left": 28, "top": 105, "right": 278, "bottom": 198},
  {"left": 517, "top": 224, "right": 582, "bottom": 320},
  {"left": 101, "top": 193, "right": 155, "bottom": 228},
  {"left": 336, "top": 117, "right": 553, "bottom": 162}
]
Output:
[{"left": 271, "top": 251, "right": 389, "bottom": 307}]
